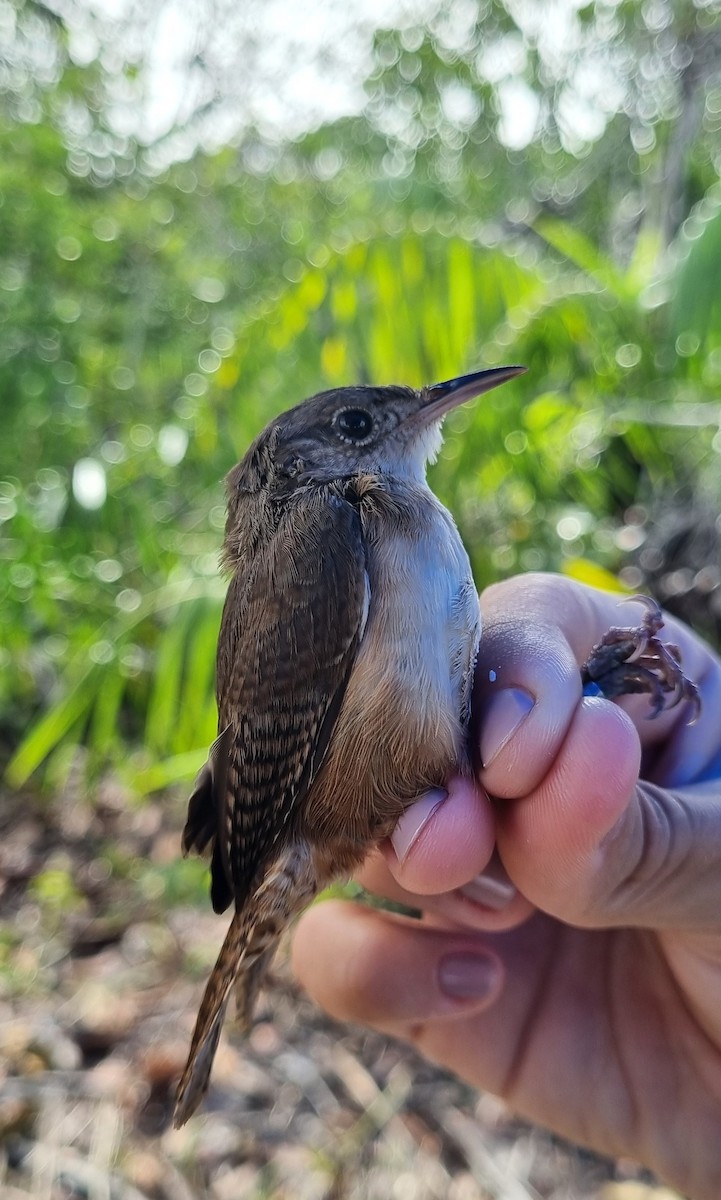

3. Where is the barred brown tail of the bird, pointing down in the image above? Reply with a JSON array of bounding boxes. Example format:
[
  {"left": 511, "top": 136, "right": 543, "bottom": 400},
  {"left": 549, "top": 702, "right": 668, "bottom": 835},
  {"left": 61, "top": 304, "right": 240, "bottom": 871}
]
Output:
[{"left": 173, "top": 845, "right": 318, "bottom": 1129}]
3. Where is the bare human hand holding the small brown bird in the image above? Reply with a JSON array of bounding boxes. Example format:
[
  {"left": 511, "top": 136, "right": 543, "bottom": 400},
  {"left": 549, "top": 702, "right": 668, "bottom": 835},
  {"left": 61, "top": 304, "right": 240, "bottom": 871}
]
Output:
[{"left": 293, "top": 575, "right": 721, "bottom": 1200}]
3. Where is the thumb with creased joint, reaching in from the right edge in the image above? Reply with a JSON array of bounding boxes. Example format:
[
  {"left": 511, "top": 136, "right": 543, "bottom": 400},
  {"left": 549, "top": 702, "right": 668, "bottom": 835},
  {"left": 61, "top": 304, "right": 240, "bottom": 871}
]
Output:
[{"left": 497, "top": 698, "right": 721, "bottom": 932}]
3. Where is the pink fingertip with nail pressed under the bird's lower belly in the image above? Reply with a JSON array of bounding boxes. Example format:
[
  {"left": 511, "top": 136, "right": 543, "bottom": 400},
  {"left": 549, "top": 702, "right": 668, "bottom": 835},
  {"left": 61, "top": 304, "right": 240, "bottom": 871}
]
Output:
[{"left": 383, "top": 776, "right": 495, "bottom": 895}]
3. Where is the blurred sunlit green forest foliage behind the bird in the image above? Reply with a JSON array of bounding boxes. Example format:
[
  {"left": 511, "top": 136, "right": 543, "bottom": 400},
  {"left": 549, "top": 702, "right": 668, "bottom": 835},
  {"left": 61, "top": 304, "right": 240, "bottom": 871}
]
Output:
[{"left": 0, "top": 0, "right": 721, "bottom": 1194}]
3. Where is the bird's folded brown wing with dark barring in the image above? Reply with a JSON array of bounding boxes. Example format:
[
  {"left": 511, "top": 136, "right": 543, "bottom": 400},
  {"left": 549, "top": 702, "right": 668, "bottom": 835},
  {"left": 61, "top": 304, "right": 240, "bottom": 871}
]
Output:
[{"left": 184, "top": 488, "right": 368, "bottom": 912}]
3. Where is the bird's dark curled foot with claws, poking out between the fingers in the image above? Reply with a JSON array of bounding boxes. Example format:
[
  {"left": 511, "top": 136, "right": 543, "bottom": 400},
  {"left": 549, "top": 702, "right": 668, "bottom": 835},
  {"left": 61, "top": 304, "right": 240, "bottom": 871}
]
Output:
[{"left": 581, "top": 595, "right": 701, "bottom": 725}]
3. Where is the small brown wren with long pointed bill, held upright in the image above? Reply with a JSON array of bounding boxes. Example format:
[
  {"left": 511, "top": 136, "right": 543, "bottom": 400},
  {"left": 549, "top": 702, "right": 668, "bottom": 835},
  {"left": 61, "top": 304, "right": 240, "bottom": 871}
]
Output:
[{"left": 174, "top": 366, "right": 525, "bottom": 1126}]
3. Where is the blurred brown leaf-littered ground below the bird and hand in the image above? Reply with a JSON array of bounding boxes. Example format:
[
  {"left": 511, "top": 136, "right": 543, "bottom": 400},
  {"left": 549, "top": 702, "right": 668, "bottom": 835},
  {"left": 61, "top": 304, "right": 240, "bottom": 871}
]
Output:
[{"left": 0, "top": 776, "right": 675, "bottom": 1200}]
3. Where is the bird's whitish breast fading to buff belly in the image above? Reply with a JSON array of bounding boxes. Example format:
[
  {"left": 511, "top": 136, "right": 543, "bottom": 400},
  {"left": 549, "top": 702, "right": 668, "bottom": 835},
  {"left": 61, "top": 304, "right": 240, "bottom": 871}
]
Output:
[{"left": 301, "top": 484, "right": 480, "bottom": 840}]
